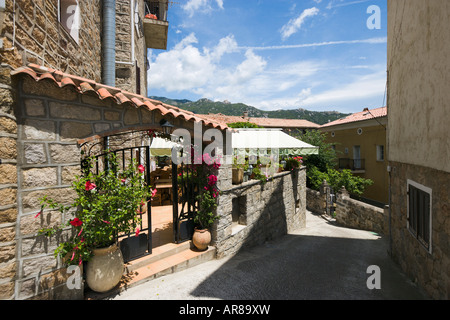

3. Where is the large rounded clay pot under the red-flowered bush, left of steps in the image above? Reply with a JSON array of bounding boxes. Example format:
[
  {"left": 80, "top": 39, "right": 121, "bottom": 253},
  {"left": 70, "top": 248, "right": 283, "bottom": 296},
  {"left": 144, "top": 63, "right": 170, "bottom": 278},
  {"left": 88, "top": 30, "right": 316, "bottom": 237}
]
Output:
[{"left": 86, "top": 244, "right": 124, "bottom": 292}]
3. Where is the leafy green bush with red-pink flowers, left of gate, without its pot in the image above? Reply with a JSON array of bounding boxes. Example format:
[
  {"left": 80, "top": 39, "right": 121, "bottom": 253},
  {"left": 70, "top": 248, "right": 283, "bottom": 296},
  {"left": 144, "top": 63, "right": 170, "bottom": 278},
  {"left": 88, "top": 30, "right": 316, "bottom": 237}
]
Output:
[{"left": 36, "top": 153, "right": 156, "bottom": 264}]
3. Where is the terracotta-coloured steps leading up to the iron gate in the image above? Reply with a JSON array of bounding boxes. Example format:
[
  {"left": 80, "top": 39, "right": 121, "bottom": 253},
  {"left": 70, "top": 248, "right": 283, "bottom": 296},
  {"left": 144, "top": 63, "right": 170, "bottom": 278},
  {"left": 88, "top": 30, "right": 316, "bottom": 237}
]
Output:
[{"left": 85, "top": 241, "right": 216, "bottom": 300}]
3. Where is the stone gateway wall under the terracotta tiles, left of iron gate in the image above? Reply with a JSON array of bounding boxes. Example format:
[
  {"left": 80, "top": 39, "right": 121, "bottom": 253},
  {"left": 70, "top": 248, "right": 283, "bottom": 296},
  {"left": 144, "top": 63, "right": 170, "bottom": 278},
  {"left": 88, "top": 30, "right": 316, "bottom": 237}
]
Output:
[{"left": 4, "top": 76, "right": 200, "bottom": 299}]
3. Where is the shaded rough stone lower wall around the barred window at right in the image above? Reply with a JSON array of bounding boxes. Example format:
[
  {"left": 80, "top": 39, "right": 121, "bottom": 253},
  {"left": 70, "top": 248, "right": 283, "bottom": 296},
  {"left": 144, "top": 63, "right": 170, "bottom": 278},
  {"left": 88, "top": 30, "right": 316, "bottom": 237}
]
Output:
[{"left": 390, "top": 162, "right": 450, "bottom": 299}]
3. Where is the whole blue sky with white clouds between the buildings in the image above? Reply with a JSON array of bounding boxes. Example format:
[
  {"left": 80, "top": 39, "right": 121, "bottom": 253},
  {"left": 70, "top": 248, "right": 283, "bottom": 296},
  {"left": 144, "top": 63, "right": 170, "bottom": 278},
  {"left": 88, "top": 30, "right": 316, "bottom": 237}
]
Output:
[{"left": 148, "top": 0, "right": 387, "bottom": 113}]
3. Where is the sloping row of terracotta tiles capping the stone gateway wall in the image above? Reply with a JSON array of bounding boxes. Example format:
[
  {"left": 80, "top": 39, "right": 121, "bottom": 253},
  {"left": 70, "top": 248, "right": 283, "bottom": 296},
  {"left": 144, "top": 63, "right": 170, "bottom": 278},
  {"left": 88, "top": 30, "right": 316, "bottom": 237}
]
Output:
[{"left": 11, "top": 64, "right": 231, "bottom": 130}]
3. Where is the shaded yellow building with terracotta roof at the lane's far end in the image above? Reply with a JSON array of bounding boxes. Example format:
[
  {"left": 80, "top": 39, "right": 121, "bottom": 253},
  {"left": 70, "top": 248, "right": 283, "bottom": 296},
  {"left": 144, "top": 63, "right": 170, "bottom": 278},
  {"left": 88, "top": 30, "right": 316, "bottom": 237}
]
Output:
[{"left": 319, "top": 107, "right": 389, "bottom": 204}]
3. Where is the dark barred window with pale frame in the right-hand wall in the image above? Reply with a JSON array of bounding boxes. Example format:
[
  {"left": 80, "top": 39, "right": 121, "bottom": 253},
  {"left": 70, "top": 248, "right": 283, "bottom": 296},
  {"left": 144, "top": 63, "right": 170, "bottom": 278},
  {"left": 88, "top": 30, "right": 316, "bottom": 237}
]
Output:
[{"left": 407, "top": 180, "right": 432, "bottom": 252}]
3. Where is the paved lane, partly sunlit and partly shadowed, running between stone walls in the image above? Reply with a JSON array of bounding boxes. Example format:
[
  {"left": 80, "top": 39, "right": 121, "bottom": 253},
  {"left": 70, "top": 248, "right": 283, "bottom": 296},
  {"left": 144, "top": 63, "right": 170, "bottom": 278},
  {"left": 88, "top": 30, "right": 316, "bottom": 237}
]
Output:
[{"left": 107, "top": 212, "right": 426, "bottom": 300}]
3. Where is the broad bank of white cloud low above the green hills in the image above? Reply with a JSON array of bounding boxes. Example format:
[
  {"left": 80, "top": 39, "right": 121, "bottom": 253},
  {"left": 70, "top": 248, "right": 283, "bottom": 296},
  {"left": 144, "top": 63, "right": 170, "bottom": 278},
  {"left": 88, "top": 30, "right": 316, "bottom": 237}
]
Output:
[{"left": 148, "top": 33, "right": 386, "bottom": 111}]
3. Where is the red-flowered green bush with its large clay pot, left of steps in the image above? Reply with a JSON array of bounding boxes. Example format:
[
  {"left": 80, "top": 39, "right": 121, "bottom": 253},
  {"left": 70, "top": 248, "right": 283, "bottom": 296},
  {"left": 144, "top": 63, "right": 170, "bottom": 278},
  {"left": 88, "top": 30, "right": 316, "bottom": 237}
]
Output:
[{"left": 39, "top": 153, "right": 156, "bottom": 292}]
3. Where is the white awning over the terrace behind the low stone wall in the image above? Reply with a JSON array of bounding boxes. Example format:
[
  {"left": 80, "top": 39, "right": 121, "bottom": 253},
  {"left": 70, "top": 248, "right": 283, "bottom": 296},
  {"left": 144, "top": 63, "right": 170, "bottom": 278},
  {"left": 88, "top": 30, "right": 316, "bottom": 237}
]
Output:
[{"left": 231, "top": 129, "right": 319, "bottom": 156}]
